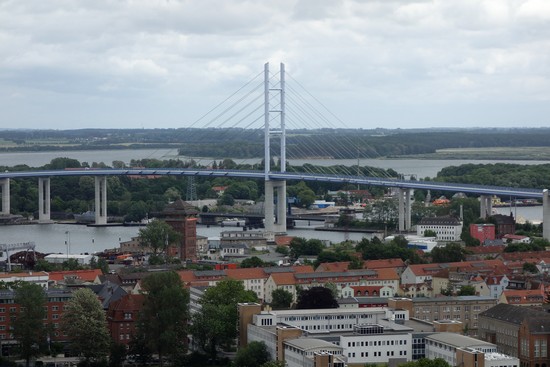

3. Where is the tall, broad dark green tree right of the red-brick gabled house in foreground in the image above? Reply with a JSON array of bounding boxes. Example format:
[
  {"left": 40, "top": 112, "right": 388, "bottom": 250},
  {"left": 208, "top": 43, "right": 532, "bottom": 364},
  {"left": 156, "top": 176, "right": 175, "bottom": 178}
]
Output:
[{"left": 137, "top": 272, "right": 189, "bottom": 366}]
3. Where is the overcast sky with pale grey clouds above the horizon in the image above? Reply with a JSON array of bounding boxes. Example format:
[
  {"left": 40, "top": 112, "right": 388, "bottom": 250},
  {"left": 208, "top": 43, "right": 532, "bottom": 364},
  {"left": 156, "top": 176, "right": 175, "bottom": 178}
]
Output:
[{"left": 0, "top": 0, "right": 550, "bottom": 129}]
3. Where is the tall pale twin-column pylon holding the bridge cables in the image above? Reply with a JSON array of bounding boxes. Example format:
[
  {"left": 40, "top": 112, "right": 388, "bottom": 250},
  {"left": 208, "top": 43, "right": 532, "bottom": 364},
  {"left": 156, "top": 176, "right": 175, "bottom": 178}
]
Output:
[{"left": 264, "top": 63, "right": 287, "bottom": 242}]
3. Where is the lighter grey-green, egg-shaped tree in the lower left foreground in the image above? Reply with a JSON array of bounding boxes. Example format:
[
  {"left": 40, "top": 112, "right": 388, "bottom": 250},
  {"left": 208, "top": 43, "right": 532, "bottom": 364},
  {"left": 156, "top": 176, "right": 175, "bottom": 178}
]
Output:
[{"left": 61, "top": 288, "right": 111, "bottom": 366}]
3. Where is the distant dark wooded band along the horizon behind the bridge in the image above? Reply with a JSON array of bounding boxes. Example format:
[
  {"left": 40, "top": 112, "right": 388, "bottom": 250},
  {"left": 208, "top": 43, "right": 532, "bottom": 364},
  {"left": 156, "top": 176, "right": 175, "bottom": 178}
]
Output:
[{"left": 0, "top": 128, "right": 550, "bottom": 159}]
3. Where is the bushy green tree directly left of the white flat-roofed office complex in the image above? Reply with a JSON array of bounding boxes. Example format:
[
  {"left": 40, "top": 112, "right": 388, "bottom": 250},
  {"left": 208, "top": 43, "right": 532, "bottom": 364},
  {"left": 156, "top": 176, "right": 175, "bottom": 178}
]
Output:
[{"left": 191, "top": 279, "right": 257, "bottom": 359}]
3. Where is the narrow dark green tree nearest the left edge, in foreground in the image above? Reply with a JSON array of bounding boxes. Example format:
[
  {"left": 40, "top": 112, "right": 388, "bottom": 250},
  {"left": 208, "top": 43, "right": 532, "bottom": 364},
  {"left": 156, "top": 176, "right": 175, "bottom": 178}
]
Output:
[{"left": 13, "top": 282, "right": 47, "bottom": 367}]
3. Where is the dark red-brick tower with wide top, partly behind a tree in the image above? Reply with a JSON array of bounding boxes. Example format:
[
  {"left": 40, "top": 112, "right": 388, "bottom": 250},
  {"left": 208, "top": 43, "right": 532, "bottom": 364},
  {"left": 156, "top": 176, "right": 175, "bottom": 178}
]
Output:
[{"left": 160, "top": 199, "right": 198, "bottom": 261}]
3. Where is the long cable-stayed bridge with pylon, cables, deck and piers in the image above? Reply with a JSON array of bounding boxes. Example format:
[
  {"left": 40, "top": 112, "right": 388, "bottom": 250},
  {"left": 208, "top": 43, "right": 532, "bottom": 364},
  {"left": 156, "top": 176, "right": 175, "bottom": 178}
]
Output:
[{"left": 0, "top": 64, "right": 550, "bottom": 239}]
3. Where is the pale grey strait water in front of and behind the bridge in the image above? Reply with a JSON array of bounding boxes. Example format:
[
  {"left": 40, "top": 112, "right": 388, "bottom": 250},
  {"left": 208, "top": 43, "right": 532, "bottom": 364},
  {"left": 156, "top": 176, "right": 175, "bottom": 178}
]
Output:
[{"left": 0, "top": 149, "right": 547, "bottom": 253}]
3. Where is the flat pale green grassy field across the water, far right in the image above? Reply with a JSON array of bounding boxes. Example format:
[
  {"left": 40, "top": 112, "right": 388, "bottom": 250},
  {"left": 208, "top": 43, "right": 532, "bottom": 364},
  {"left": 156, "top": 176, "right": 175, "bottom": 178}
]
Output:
[{"left": 402, "top": 147, "right": 550, "bottom": 161}]
